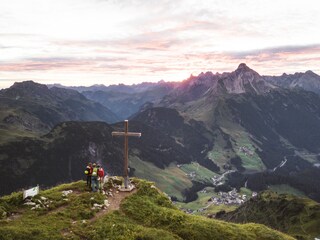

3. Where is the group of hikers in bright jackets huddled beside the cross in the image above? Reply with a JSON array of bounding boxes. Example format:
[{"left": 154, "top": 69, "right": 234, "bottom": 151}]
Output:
[{"left": 84, "top": 163, "right": 104, "bottom": 192}]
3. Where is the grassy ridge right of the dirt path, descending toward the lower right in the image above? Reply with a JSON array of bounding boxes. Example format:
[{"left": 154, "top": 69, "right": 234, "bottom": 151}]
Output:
[{"left": 115, "top": 182, "right": 296, "bottom": 240}]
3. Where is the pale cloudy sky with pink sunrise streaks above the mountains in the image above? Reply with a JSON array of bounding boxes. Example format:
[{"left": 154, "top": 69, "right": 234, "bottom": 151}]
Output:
[{"left": 0, "top": 0, "right": 320, "bottom": 88}]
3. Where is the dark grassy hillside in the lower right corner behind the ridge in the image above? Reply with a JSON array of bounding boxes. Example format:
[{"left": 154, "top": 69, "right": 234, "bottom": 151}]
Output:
[{"left": 222, "top": 191, "right": 320, "bottom": 240}]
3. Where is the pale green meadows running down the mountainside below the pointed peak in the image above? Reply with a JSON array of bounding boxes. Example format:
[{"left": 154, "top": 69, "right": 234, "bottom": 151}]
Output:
[{"left": 181, "top": 93, "right": 266, "bottom": 172}]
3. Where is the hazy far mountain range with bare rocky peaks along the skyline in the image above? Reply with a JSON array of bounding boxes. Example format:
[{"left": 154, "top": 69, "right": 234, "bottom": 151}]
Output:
[{"left": 48, "top": 63, "right": 320, "bottom": 120}]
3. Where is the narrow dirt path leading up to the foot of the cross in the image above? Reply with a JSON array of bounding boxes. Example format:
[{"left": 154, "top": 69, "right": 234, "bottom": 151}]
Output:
[{"left": 90, "top": 188, "right": 137, "bottom": 222}]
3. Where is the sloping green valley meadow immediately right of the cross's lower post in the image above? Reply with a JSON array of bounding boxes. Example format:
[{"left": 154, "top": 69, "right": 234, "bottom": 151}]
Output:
[{"left": 130, "top": 156, "right": 192, "bottom": 201}]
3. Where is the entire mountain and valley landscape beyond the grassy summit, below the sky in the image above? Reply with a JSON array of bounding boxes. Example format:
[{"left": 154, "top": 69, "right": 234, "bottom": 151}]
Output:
[{"left": 0, "top": 64, "right": 320, "bottom": 240}]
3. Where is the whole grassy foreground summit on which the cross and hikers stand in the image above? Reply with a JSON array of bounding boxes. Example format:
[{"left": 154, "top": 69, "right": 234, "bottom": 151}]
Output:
[{"left": 0, "top": 180, "right": 293, "bottom": 240}]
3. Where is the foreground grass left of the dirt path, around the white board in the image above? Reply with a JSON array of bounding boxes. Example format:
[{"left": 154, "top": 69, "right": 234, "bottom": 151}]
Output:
[{"left": 0, "top": 181, "right": 104, "bottom": 239}]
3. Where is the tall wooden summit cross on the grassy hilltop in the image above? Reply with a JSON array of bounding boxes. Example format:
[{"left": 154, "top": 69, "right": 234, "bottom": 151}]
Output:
[{"left": 111, "top": 120, "right": 141, "bottom": 189}]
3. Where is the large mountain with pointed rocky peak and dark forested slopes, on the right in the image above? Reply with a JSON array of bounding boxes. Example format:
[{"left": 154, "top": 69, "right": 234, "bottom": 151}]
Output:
[{"left": 133, "top": 64, "right": 320, "bottom": 201}]
